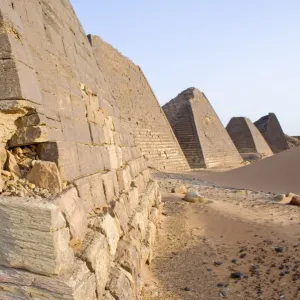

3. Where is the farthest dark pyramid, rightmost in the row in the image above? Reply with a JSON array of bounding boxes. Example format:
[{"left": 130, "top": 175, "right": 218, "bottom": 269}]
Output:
[{"left": 254, "top": 113, "right": 289, "bottom": 153}]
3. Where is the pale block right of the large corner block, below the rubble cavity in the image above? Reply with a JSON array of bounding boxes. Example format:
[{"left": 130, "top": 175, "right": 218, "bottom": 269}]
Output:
[{"left": 53, "top": 187, "right": 88, "bottom": 241}]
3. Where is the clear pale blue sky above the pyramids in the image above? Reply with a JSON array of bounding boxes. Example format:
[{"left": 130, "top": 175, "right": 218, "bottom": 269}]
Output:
[{"left": 71, "top": 0, "right": 300, "bottom": 135}]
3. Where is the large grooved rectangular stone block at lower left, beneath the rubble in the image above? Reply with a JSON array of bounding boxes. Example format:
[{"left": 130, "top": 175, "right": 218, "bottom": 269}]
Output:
[{"left": 0, "top": 197, "right": 73, "bottom": 275}]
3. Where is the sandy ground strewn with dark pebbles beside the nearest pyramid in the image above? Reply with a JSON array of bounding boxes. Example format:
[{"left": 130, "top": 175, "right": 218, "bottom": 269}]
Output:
[{"left": 142, "top": 174, "right": 300, "bottom": 300}]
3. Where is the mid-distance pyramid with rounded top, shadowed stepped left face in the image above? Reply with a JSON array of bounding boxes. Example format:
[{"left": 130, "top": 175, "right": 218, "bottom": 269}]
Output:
[{"left": 163, "top": 88, "right": 243, "bottom": 168}]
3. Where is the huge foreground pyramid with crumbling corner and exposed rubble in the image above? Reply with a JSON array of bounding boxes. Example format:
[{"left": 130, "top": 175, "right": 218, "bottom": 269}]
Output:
[{"left": 0, "top": 0, "right": 161, "bottom": 300}]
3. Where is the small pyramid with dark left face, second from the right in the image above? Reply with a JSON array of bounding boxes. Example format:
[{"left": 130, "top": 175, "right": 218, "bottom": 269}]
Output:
[{"left": 226, "top": 117, "right": 272, "bottom": 155}]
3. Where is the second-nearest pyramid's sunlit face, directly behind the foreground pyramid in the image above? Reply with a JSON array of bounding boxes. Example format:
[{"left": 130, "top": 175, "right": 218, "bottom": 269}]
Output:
[{"left": 89, "top": 36, "right": 189, "bottom": 171}]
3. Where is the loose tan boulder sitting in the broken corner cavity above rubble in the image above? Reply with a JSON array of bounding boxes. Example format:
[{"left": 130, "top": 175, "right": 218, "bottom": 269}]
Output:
[{"left": 27, "top": 160, "right": 62, "bottom": 194}]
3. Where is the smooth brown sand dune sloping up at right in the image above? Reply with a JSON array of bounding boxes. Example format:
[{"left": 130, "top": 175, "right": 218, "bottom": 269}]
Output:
[{"left": 198, "top": 147, "right": 300, "bottom": 194}]
